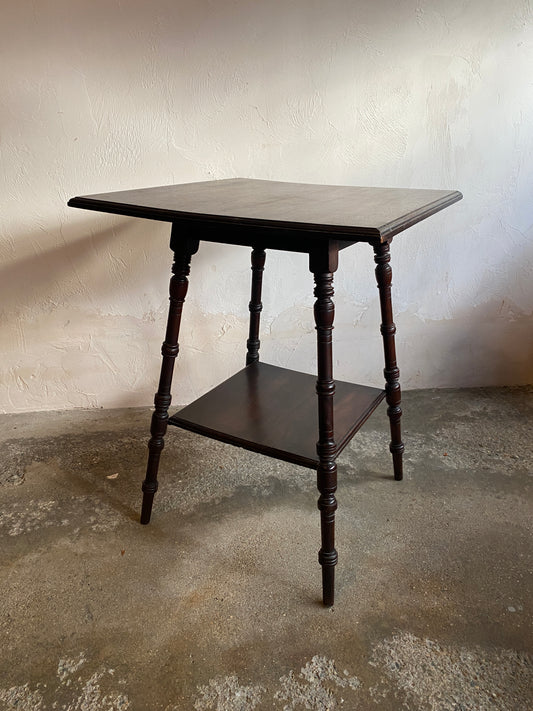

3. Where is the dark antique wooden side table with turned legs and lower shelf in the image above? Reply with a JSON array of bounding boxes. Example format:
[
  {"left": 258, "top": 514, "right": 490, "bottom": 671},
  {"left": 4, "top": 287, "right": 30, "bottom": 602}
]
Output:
[{"left": 68, "top": 178, "right": 462, "bottom": 606}]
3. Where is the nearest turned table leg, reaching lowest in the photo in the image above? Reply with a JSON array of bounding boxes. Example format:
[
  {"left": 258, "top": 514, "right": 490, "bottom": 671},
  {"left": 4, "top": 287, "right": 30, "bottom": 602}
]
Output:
[{"left": 314, "top": 264, "right": 338, "bottom": 606}]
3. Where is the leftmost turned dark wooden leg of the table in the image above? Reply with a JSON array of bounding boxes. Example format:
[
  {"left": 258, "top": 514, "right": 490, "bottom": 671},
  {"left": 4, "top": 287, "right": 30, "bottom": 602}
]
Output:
[{"left": 141, "top": 236, "right": 198, "bottom": 524}]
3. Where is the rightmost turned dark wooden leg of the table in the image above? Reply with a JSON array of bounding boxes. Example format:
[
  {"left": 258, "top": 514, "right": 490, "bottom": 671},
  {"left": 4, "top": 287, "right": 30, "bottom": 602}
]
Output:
[{"left": 374, "top": 243, "right": 405, "bottom": 481}]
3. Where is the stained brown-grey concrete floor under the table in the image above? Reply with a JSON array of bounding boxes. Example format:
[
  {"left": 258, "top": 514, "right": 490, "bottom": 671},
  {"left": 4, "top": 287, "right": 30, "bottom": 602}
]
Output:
[{"left": 0, "top": 388, "right": 533, "bottom": 711}]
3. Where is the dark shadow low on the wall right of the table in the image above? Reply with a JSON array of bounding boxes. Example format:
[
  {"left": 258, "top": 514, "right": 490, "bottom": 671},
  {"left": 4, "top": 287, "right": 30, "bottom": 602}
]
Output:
[{"left": 397, "top": 234, "right": 533, "bottom": 389}]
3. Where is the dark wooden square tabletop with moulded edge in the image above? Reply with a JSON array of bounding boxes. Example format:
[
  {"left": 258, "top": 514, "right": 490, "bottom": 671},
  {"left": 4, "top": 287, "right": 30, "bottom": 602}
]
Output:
[{"left": 68, "top": 178, "right": 462, "bottom": 244}]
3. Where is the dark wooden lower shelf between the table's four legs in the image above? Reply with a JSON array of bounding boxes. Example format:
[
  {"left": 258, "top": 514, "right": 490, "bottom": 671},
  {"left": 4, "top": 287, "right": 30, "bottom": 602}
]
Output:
[{"left": 169, "top": 363, "right": 385, "bottom": 468}]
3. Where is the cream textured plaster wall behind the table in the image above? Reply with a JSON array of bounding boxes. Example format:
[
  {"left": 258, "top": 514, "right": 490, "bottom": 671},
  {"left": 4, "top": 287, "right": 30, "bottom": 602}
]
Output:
[{"left": 0, "top": 0, "right": 533, "bottom": 411}]
